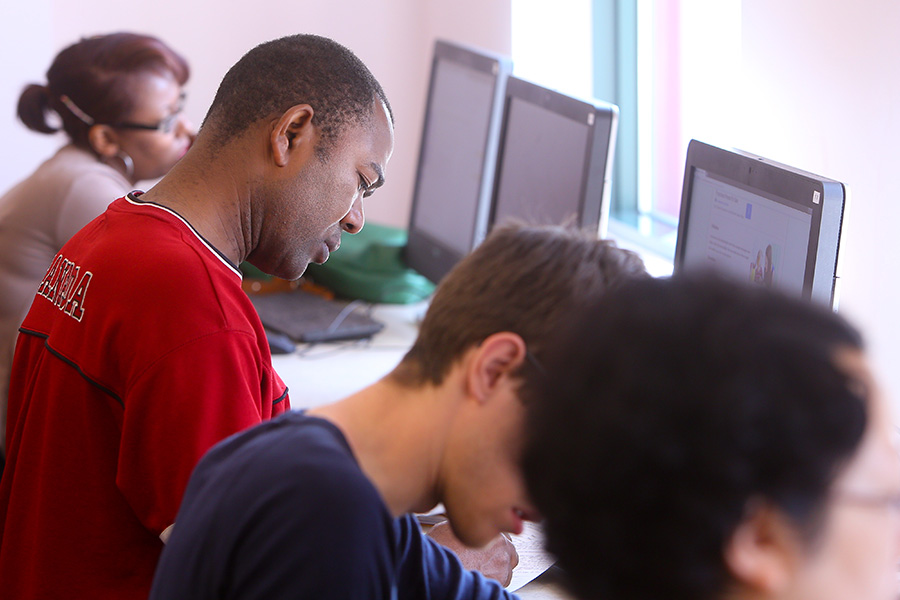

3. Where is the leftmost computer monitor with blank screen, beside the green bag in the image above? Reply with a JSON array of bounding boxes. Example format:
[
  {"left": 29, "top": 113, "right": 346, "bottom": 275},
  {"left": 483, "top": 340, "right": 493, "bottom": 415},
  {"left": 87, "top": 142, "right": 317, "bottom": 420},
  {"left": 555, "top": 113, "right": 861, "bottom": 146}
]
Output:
[{"left": 404, "top": 40, "right": 512, "bottom": 282}]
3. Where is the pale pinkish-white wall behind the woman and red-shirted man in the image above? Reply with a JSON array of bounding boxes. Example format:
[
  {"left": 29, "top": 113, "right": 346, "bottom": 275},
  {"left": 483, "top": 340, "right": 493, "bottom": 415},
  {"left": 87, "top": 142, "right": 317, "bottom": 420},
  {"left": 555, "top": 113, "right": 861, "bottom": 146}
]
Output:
[{"left": 0, "top": 0, "right": 510, "bottom": 226}]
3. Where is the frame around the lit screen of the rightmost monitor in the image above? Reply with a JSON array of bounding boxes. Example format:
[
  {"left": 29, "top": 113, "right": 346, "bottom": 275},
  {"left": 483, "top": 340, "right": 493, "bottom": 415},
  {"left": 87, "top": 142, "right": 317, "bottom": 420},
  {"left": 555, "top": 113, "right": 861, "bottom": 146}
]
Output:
[{"left": 673, "top": 140, "right": 848, "bottom": 309}]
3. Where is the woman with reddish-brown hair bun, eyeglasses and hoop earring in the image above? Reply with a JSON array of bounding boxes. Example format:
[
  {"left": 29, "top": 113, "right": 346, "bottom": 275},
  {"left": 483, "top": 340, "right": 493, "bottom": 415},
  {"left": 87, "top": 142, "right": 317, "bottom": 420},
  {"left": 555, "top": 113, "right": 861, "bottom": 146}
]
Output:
[{"left": 0, "top": 33, "right": 194, "bottom": 465}]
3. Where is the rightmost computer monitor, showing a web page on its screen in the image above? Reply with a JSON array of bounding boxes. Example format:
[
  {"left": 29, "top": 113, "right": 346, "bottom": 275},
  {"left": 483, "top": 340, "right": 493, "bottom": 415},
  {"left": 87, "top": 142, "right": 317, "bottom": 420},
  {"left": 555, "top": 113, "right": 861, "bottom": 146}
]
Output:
[{"left": 674, "top": 140, "right": 847, "bottom": 309}]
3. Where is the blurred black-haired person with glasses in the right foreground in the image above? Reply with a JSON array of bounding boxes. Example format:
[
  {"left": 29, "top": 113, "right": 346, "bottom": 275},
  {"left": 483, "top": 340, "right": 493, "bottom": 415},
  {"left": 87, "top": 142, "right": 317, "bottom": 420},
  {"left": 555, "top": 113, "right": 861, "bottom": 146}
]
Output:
[{"left": 524, "top": 275, "right": 900, "bottom": 600}]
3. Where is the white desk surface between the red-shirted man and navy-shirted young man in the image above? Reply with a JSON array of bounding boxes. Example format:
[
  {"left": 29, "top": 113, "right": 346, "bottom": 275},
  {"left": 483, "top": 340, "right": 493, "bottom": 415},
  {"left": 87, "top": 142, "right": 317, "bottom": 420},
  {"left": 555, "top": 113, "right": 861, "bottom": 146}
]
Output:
[{"left": 272, "top": 302, "right": 568, "bottom": 600}]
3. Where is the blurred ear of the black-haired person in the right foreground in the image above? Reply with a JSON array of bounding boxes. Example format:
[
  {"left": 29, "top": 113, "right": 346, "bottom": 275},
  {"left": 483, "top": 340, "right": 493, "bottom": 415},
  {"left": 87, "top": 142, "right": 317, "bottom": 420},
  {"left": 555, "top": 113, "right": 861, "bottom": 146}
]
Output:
[{"left": 725, "top": 502, "right": 803, "bottom": 594}]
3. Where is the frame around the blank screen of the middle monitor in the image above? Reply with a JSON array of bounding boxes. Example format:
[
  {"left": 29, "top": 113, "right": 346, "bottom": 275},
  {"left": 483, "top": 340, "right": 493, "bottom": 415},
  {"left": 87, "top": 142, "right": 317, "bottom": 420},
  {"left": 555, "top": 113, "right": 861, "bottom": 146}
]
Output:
[{"left": 490, "top": 76, "right": 619, "bottom": 237}]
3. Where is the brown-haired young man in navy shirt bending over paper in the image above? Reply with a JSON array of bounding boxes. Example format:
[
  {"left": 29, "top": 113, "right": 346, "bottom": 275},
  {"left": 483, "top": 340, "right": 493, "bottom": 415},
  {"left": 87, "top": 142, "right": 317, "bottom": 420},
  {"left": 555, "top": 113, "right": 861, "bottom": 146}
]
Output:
[{"left": 150, "top": 225, "right": 646, "bottom": 600}]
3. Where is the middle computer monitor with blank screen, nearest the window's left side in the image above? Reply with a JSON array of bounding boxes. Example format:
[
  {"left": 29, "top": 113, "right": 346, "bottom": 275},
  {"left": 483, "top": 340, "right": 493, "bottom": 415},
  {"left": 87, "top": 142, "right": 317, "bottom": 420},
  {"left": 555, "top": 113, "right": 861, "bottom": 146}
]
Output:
[{"left": 491, "top": 77, "right": 619, "bottom": 236}]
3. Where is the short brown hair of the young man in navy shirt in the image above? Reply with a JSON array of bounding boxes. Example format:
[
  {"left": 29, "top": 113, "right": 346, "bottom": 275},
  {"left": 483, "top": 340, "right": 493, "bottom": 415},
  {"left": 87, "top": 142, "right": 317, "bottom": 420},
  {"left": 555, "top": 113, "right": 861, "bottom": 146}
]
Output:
[{"left": 394, "top": 223, "right": 646, "bottom": 385}]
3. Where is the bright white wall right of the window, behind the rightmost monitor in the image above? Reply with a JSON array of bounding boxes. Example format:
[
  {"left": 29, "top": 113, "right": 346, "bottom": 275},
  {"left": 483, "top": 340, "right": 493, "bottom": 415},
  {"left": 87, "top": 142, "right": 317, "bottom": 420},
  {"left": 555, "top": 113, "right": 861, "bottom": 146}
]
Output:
[{"left": 733, "top": 0, "right": 900, "bottom": 407}]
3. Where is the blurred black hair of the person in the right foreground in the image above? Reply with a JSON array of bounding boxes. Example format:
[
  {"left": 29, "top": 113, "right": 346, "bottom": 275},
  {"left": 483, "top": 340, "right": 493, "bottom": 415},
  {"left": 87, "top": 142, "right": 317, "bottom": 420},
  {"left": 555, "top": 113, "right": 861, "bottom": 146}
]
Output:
[{"left": 524, "top": 275, "right": 867, "bottom": 600}]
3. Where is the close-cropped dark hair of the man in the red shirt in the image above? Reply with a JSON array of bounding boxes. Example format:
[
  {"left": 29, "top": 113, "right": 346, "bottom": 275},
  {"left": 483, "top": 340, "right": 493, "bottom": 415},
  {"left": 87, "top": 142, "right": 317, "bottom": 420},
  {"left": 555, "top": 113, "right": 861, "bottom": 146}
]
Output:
[{"left": 203, "top": 34, "right": 393, "bottom": 156}]
